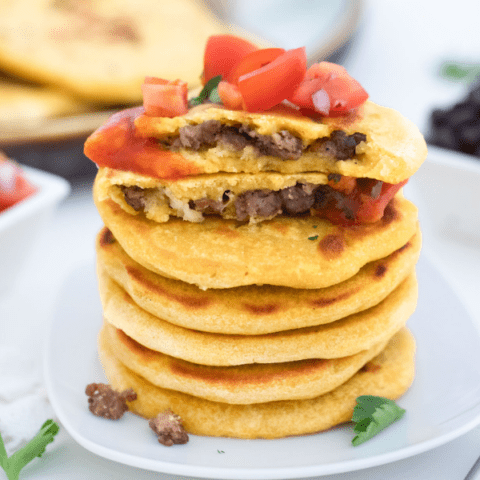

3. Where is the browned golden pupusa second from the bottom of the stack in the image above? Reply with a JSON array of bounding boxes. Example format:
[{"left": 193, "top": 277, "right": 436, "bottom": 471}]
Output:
[{"left": 100, "top": 323, "right": 387, "bottom": 404}]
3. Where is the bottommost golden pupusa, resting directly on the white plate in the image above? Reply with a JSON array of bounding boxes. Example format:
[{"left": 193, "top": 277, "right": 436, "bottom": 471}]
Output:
[{"left": 99, "top": 329, "right": 415, "bottom": 438}]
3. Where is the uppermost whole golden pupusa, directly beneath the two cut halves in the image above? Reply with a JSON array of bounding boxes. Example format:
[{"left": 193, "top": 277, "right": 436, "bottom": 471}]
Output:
[{"left": 94, "top": 178, "right": 418, "bottom": 288}]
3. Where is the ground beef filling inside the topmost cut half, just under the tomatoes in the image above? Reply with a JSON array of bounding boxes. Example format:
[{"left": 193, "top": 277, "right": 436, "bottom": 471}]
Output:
[{"left": 161, "top": 120, "right": 367, "bottom": 160}]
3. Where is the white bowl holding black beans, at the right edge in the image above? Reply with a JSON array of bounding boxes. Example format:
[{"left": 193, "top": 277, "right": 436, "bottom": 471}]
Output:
[{"left": 405, "top": 146, "right": 480, "bottom": 247}]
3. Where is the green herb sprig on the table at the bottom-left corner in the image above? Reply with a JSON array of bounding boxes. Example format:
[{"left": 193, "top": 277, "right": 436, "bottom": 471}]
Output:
[{"left": 0, "top": 420, "right": 60, "bottom": 480}]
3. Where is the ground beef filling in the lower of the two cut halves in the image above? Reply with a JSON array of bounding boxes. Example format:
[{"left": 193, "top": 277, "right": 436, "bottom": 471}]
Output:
[{"left": 122, "top": 179, "right": 382, "bottom": 221}]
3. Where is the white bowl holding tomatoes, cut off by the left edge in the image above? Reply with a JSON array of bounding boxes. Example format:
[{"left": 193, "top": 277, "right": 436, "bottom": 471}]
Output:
[{"left": 0, "top": 166, "right": 70, "bottom": 294}]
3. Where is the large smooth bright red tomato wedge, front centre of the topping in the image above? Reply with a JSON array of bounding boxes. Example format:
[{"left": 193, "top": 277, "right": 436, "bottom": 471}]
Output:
[{"left": 238, "top": 47, "right": 307, "bottom": 112}]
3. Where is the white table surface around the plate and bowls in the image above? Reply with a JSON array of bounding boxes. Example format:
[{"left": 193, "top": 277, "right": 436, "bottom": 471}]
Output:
[{"left": 0, "top": 0, "right": 480, "bottom": 480}]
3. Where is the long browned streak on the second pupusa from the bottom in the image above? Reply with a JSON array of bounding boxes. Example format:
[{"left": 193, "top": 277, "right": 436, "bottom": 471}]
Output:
[{"left": 170, "top": 358, "right": 332, "bottom": 387}]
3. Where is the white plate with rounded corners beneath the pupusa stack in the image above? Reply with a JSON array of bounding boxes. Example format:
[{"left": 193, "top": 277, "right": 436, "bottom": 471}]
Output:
[{"left": 45, "top": 255, "right": 480, "bottom": 479}]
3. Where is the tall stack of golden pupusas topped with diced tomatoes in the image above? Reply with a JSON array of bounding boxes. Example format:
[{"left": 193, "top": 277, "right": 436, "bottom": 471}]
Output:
[{"left": 85, "top": 37, "right": 426, "bottom": 438}]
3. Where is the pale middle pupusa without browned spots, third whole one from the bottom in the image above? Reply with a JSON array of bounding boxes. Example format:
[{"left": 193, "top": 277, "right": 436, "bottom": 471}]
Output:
[{"left": 99, "top": 272, "right": 418, "bottom": 366}]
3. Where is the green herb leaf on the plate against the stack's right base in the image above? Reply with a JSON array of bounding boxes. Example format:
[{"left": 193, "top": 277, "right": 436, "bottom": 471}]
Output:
[{"left": 352, "top": 395, "right": 405, "bottom": 447}]
